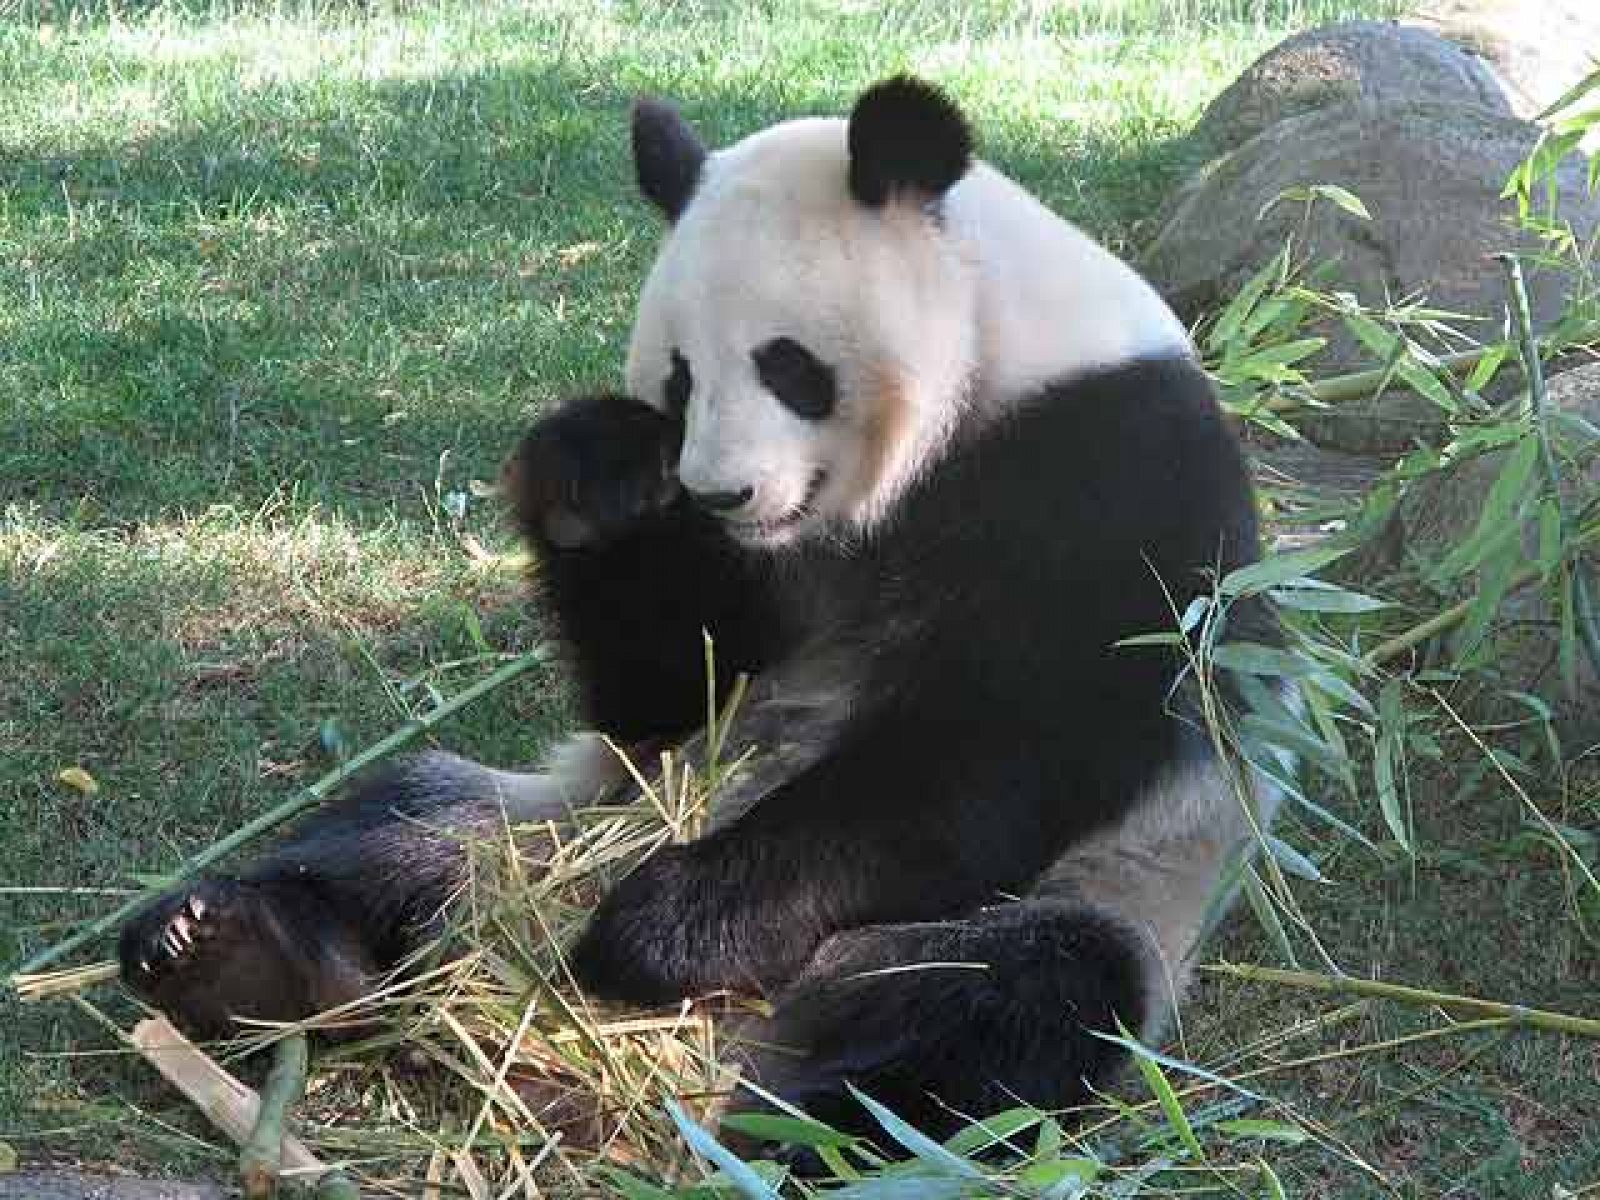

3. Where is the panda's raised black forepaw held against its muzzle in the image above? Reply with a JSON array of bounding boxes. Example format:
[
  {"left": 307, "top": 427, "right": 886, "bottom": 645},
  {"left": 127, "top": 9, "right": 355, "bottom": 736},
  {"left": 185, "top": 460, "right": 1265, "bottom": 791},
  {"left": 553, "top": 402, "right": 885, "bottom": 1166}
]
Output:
[{"left": 501, "top": 395, "right": 682, "bottom": 549}]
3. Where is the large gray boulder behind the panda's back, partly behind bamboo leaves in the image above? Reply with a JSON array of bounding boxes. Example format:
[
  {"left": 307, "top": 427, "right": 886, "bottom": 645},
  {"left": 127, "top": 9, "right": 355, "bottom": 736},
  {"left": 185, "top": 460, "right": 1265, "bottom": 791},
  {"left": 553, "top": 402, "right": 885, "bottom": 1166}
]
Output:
[{"left": 1142, "top": 101, "right": 1600, "bottom": 453}]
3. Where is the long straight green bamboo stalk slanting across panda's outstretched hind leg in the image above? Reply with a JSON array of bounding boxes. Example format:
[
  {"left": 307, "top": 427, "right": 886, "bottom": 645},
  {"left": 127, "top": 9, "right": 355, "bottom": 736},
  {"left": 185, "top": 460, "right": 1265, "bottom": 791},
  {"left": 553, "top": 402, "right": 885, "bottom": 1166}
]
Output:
[{"left": 11, "top": 648, "right": 546, "bottom": 986}]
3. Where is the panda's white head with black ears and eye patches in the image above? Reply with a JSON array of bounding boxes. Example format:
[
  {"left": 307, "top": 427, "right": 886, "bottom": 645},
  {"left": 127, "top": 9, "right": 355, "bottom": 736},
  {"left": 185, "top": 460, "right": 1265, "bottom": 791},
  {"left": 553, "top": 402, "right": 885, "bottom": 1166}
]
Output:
[{"left": 627, "top": 78, "right": 976, "bottom": 546}]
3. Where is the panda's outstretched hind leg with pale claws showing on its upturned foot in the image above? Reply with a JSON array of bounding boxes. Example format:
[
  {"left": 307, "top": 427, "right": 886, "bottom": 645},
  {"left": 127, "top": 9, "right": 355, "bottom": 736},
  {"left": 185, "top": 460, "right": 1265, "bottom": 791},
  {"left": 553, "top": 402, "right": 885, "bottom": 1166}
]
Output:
[{"left": 120, "top": 752, "right": 614, "bottom": 1037}]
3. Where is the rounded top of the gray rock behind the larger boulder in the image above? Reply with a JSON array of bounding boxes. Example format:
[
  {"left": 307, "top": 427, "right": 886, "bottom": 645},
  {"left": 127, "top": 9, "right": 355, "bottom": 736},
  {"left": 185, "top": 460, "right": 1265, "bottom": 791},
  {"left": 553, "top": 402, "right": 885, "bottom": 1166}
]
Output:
[{"left": 1195, "top": 21, "right": 1512, "bottom": 154}]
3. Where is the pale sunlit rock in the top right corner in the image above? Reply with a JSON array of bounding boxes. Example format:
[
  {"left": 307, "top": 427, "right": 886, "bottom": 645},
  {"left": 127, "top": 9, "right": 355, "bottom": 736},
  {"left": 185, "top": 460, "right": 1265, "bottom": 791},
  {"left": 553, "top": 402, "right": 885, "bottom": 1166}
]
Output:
[{"left": 1405, "top": 0, "right": 1600, "bottom": 117}]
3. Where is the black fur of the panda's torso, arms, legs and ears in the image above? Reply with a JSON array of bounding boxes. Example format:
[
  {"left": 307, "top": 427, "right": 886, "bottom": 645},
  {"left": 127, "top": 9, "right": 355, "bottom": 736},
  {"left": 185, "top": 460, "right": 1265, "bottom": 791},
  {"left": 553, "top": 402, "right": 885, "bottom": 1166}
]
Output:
[{"left": 120, "top": 82, "right": 1270, "bottom": 1130}]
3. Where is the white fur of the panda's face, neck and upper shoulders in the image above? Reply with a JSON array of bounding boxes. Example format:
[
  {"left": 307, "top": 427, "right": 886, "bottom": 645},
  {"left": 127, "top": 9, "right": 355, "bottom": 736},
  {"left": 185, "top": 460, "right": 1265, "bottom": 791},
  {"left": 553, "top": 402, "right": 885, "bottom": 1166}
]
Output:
[{"left": 627, "top": 118, "right": 1189, "bottom": 542}]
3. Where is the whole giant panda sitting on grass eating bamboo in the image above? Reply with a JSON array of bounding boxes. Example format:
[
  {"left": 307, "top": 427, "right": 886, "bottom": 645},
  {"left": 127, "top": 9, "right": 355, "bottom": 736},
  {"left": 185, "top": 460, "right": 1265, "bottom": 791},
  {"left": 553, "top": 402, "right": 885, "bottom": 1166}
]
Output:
[{"left": 120, "top": 77, "right": 1275, "bottom": 1131}]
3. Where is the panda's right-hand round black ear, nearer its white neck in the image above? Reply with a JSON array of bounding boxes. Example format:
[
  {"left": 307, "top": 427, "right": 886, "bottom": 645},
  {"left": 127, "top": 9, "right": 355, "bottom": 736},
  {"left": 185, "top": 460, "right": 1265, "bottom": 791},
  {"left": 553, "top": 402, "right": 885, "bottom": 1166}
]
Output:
[{"left": 850, "top": 75, "right": 973, "bottom": 208}]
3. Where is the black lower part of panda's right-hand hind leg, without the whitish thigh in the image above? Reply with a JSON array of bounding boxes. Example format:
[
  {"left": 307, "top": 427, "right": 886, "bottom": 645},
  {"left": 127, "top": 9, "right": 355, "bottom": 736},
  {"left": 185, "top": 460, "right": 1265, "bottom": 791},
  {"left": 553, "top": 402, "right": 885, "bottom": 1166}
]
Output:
[{"left": 736, "top": 901, "right": 1150, "bottom": 1136}]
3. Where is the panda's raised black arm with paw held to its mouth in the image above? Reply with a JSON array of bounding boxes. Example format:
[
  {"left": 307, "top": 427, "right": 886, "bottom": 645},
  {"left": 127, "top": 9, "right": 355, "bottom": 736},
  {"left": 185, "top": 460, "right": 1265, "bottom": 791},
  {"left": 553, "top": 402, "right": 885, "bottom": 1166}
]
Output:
[{"left": 504, "top": 395, "right": 781, "bottom": 742}]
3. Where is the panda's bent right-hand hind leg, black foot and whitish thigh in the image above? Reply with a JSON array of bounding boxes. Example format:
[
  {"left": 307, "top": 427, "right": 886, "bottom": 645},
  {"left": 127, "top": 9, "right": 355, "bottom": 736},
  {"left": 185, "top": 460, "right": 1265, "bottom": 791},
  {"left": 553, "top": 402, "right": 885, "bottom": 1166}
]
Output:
[{"left": 732, "top": 752, "right": 1277, "bottom": 1134}]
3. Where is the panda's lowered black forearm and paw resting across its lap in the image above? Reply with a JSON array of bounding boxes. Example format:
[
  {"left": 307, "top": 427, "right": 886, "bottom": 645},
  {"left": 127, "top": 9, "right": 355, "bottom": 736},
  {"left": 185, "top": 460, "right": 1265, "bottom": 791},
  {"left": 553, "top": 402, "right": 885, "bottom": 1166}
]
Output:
[{"left": 571, "top": 691, "right": 1160, "bottom": 1003}]
